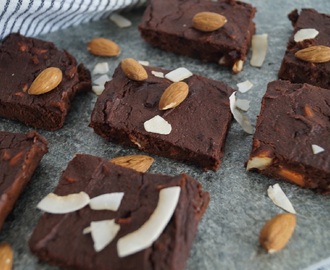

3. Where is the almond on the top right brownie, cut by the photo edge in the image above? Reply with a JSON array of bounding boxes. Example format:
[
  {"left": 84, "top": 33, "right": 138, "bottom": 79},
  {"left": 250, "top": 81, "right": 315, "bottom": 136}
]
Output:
[{"left": 295, "top": 45, "right": 330, "bottom": 63}]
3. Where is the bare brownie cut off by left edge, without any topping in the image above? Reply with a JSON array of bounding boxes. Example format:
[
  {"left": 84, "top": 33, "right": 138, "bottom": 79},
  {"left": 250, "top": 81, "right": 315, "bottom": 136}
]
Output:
[{"left": 0, "top": 131, "right": 48, "bottom": 229}]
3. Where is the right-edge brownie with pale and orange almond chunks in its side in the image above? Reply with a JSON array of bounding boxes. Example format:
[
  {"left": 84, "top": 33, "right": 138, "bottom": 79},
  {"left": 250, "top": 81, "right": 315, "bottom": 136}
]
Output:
[{"left": 247, "top": 81, "right": 330, "bottom": 193}]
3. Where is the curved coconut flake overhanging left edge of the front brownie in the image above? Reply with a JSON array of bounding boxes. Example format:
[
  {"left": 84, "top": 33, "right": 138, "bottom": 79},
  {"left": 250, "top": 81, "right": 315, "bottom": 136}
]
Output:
[{"left": 37, "top": 191, "right": 90, "bottom": 214}]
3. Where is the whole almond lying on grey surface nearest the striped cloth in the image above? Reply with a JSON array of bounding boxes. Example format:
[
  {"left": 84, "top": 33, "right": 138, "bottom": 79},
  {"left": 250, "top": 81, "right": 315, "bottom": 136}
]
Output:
[{"left": 87, "top": 38, "right": 120, "bottom": 56}]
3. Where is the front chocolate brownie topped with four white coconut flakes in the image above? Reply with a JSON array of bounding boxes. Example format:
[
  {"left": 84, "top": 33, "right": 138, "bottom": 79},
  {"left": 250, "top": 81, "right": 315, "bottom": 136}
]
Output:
[{"left": 29, "top": 154, "right": 209, "bottom": 270}]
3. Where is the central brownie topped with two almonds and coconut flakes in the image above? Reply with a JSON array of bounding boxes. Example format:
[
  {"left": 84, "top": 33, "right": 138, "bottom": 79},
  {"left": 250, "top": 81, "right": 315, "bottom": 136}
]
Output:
[{"left": 90, "top": 64, "right": 234, "bottom": 170}]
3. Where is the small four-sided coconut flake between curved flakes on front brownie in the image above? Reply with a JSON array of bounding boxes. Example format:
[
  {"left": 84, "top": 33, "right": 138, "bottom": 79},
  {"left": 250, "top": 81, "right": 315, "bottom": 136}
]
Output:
[{"left": 89, "top": 192, "right": 124, "bottom": 211}]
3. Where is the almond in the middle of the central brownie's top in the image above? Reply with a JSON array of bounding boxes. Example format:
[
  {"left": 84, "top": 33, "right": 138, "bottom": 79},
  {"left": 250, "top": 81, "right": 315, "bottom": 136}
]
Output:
[{"left": 159, "top": 82, "right": 189, "bottom": 110}]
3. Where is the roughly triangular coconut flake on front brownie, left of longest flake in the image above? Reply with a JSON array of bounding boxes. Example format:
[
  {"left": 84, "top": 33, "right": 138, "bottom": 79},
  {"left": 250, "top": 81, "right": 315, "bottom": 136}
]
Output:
[{"left": 91, "top": 219, "right": 120, "bottom": 252}]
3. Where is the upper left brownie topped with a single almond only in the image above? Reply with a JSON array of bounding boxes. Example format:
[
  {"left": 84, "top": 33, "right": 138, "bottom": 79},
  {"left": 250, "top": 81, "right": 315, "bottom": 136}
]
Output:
[{"left": 0, "top": 34, "right": 91, "bottom": 130}]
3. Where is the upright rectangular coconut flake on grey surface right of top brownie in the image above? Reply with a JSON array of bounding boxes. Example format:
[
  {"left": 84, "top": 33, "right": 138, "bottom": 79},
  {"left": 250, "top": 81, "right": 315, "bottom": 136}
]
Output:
[{"left": 250, "top": 34, "right": 268, "bottom": 67}]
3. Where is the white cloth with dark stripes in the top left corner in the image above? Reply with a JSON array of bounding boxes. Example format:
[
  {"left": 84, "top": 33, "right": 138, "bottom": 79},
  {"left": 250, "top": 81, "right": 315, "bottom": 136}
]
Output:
[{"left": 0, "top": 0, "right": 145, "bottom": 40}]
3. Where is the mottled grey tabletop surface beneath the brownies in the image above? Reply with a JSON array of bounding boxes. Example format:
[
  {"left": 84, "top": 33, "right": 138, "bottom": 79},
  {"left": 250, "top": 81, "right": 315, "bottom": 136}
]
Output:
[{"left": 0, "top": 0, "right": 330, "bottom": 270}]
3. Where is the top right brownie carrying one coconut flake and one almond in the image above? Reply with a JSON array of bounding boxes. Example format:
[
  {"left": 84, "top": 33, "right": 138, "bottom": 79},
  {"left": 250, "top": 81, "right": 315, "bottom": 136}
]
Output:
[{"left": 278, "top": 9, "right": 330, "bottom": 89}]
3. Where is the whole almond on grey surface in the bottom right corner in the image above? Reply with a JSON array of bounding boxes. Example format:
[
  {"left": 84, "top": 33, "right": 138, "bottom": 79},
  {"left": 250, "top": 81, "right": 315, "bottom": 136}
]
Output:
[{"left": 259, "top": 213, "right": 296, "bottom": 253}]
